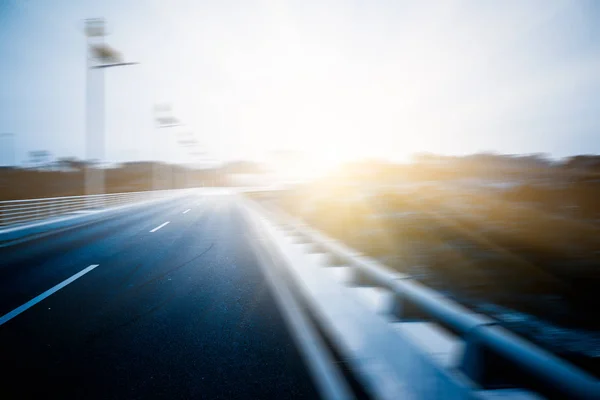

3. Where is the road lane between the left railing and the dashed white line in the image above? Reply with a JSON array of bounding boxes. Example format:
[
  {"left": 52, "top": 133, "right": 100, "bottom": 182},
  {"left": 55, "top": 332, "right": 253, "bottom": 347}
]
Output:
[{"left": 0, "top": 195, "right": 203, "bottom": 315}]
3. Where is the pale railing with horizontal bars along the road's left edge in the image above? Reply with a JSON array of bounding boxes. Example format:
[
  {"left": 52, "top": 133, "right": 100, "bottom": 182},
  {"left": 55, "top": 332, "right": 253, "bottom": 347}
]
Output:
[{"left": 0, "top": 190, "right": 182, "bottom": 227}]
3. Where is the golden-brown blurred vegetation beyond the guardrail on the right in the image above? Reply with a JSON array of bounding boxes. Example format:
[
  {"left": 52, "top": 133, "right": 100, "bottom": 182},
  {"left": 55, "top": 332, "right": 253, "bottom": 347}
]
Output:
[{"left": 247, "top": 152, "right": 600, "bottom": 375}]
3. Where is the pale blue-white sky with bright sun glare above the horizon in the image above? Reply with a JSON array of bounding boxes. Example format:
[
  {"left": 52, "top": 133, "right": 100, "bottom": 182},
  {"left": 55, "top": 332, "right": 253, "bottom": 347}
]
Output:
[{"left": 0, "top": 0, "right": 600, "bottom": 164}]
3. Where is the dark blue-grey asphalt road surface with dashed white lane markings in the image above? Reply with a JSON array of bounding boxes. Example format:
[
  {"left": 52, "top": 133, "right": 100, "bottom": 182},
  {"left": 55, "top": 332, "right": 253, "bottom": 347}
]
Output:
[{"left": 0, "top": 195, "right": 318, "bottom": 399}]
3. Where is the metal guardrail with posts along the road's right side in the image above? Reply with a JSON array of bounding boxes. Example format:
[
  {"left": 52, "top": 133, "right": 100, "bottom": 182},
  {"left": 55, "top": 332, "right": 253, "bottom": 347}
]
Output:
[{"left": 261, "top": 207, "right": 600, "bottom": 399}]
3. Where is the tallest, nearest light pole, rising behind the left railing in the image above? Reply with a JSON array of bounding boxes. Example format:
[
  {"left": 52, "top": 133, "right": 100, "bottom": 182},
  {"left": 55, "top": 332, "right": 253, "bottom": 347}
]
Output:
[{"left": 85, "top": 18, "right": 137, "bottom": 198}]
